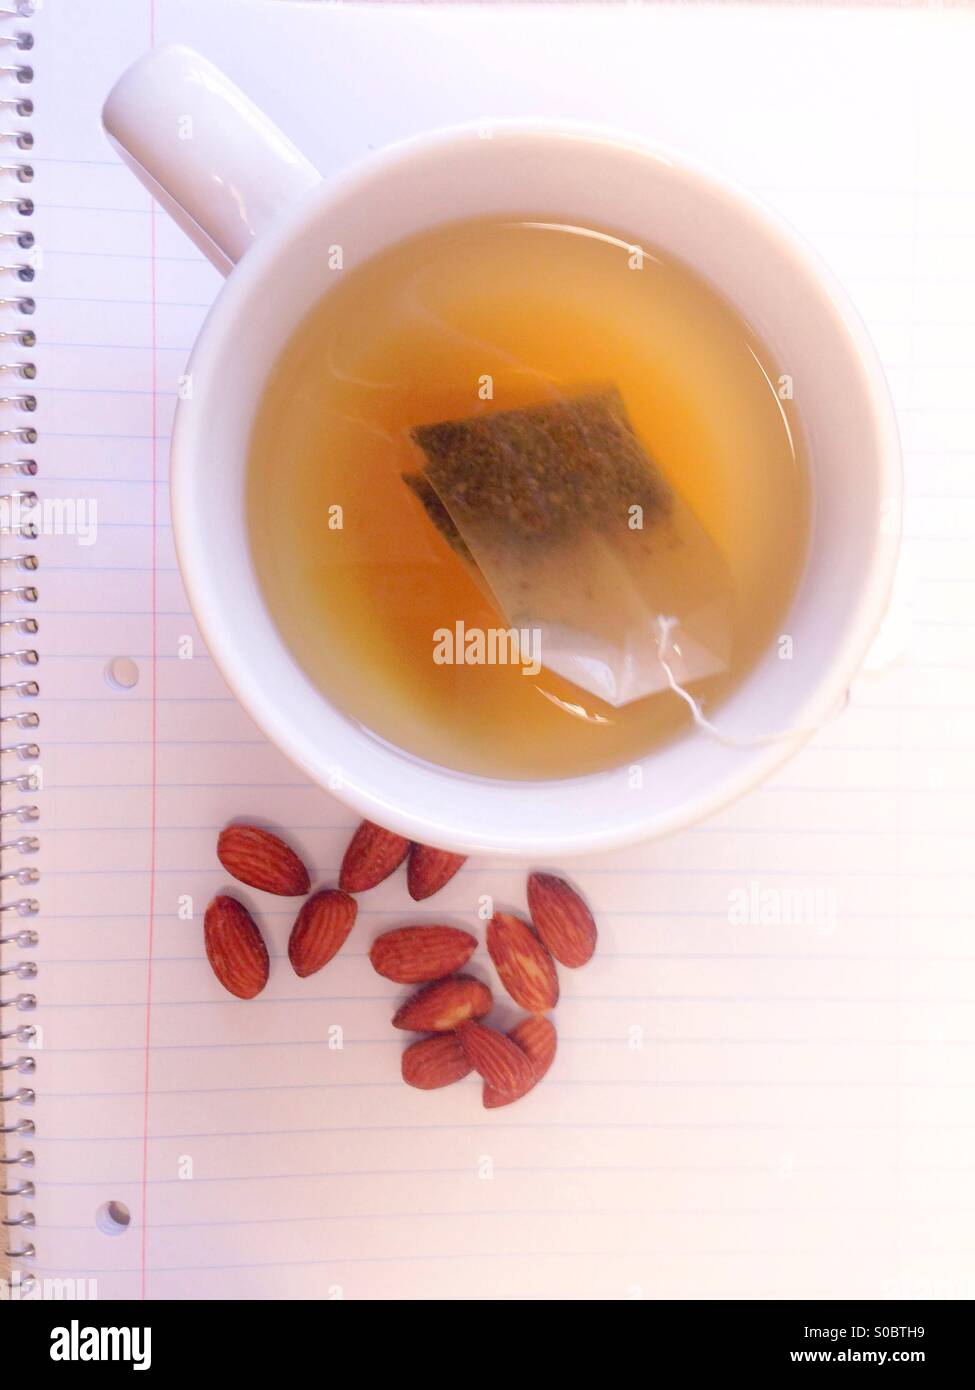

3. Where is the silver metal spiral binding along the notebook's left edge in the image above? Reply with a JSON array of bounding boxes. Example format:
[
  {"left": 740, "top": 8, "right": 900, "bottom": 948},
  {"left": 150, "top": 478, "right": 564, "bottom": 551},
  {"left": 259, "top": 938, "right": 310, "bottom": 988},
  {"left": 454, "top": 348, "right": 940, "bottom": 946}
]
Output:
[{"left": 0, "top": 0, "right": 34, "bottom": 1294}]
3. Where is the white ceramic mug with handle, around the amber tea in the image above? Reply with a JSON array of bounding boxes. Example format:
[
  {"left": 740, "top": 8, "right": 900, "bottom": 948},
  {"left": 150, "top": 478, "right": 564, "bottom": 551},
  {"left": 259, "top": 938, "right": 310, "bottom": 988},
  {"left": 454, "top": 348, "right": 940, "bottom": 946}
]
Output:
[{"left": 104, "top": 47, "right": 901, "bottom": 860}]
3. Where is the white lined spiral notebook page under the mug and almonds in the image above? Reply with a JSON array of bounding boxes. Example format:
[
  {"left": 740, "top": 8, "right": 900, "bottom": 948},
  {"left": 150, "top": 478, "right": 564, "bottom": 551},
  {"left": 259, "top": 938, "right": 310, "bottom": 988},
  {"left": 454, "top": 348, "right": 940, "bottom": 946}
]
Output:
[{"left": 0, "top": 0, "right": 975, "bottom": 1298}]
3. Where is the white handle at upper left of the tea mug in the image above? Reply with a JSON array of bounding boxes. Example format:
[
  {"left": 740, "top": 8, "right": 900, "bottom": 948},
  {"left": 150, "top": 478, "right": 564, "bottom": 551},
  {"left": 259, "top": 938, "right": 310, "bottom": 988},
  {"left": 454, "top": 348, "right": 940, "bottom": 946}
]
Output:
[{"left": 102, "top": 43, "right": 321, "bottom": 275}]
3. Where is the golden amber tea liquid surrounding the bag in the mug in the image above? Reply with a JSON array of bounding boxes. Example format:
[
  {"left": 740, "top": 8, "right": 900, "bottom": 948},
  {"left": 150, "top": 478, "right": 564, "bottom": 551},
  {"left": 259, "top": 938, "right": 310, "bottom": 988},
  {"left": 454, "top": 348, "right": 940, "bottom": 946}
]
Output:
[{"left": 248, "top": 221, "right": 808, "bottom": 778}]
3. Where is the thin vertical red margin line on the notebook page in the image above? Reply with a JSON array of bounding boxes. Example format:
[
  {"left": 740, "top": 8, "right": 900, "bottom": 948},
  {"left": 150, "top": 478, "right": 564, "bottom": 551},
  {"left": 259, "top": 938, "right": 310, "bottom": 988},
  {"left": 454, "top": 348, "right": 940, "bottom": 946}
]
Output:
[{"left": 139, "top": 0, "right": 159, "bottom": 1298}]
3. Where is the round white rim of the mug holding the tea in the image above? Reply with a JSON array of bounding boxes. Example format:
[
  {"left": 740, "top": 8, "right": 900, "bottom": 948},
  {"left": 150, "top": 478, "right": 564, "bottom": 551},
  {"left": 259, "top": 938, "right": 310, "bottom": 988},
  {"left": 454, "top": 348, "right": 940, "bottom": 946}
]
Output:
[{"left": 171, "top": 120, "right": 901, "bottom": 855}]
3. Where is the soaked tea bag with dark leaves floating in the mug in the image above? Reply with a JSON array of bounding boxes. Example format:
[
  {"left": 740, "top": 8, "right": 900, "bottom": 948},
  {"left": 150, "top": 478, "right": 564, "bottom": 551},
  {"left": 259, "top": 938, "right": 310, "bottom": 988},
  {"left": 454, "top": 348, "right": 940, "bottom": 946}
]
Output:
[{"left": 405, "top": 388, "right": 732, "bottom": 706}]
